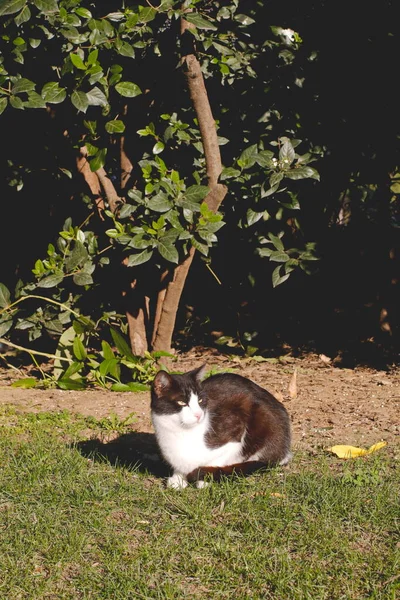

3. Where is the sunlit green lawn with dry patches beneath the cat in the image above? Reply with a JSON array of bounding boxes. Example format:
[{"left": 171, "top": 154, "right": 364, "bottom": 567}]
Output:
[{"left": 0, "top": 408, "right": 400, "bottom": 600}]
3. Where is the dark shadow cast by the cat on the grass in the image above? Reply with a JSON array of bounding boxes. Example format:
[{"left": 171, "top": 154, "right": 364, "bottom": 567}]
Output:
[{"left": 74, "top": 431, "right": 171, "bottom": 478}]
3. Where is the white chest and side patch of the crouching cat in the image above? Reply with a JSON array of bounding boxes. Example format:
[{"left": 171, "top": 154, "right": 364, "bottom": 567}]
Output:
[{"left": 152, "top": 413, "right": 242, "bottom": 475}]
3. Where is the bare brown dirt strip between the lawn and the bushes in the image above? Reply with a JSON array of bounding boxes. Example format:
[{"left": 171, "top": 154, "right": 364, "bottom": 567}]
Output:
[{"left": 0, "top": 348, "right": 400, "bottom": 452}]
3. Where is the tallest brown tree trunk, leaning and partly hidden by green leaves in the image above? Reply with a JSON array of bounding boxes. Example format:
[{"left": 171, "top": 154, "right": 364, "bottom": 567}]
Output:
[{"left": 153, "top": 19, "right": 227, "bottom": 351}]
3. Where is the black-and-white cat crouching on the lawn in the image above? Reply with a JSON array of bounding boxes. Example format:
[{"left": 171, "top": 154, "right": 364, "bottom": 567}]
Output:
[{"left": 151, "top": 365, "right": 292, "bottom": 489}]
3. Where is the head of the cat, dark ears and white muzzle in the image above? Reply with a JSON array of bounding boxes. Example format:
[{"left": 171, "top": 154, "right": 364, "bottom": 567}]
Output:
[{"left": 151, "top": 365, "right": 206, "bottom": 427}]
